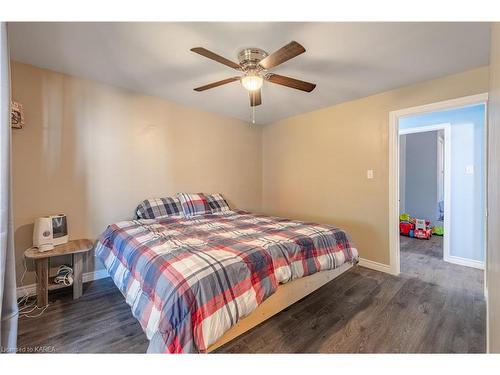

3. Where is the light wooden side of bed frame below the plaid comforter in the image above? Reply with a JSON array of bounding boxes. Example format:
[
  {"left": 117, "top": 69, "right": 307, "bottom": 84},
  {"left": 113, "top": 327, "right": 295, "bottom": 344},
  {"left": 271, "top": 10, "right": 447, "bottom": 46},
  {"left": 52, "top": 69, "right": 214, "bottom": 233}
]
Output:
[{"left": 207, "top": 263, "right": 353, "bottom": 353}]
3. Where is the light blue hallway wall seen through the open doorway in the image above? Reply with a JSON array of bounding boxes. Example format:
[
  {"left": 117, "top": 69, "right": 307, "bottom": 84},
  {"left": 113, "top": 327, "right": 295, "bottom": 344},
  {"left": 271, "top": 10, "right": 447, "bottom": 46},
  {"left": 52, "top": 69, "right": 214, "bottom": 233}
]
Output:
[{"left": 399, "top": 104, "right": 486, "bottom": 261}]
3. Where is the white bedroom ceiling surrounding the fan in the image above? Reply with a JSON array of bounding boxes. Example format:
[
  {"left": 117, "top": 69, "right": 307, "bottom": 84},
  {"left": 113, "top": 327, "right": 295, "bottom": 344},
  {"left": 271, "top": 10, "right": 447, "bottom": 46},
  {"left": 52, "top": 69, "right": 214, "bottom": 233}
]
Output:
[{"left": 8, "top": 22, "right": 489, "bottom": 124}]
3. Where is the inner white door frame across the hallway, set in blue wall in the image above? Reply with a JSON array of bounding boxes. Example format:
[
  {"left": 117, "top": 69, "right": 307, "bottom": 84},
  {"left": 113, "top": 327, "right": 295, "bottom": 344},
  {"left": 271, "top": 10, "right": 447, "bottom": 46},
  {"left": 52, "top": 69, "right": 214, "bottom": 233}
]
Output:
[{"left": 398, "top": 123, "right": 453, "bottom": 263}]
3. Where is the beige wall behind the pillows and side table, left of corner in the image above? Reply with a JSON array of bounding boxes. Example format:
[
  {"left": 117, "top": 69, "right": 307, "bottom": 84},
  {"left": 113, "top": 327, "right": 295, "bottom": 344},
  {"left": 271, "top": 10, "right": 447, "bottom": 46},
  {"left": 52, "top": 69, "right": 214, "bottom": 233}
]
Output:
[{"left": 12, "top": 62, "right": 262, "bottom": 285}]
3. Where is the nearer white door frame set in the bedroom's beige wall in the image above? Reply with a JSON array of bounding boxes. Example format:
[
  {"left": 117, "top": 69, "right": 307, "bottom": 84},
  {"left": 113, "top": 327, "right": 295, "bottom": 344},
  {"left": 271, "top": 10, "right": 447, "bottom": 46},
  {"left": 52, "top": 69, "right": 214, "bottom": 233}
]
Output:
[{"left": 389, "top": 93, "right": 488, "bottom": 275}]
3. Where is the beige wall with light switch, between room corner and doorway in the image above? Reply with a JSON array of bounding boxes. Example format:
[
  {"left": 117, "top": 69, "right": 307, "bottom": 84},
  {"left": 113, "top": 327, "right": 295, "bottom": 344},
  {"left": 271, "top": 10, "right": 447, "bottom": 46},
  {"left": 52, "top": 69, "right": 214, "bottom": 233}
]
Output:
[{"left": 263, "top": 67, "right": 488, "bottom": 264}]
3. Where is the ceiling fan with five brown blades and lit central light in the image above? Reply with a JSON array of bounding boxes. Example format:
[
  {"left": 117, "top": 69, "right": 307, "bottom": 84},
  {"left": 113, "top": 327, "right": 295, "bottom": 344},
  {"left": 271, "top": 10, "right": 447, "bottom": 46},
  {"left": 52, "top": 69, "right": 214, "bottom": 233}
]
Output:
[{"left": 191, "top": 41, "right": 316, "bottom": 107}]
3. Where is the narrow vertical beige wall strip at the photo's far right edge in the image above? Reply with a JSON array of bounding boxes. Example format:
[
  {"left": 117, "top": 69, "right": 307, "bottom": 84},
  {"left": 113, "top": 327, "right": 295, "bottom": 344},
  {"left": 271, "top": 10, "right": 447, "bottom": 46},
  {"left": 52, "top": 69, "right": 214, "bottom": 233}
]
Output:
[{"left": 486, "top": 23, "right": 500, "bottom": 353}]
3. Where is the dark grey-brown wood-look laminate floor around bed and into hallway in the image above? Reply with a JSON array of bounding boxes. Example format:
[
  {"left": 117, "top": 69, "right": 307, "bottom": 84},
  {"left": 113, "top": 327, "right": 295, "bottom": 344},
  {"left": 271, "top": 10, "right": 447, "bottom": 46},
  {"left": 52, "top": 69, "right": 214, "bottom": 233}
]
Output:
[{"left": 18, "top": 237, "right": 486, "bottom": 353}]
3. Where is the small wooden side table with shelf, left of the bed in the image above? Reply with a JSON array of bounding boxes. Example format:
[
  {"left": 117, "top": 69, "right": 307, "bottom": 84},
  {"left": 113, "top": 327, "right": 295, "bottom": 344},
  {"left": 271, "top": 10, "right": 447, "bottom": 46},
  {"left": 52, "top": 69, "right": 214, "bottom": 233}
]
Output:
[{"left": 24, "top": 239, "right": 93, "bottom": 307}]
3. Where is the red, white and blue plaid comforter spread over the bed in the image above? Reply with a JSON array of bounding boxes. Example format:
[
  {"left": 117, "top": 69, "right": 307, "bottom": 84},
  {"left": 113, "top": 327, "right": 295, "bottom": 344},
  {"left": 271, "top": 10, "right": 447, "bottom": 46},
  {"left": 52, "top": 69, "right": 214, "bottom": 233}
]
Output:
[{"left": 96, "top": 211, "right": 358, "bottom": 353}]
